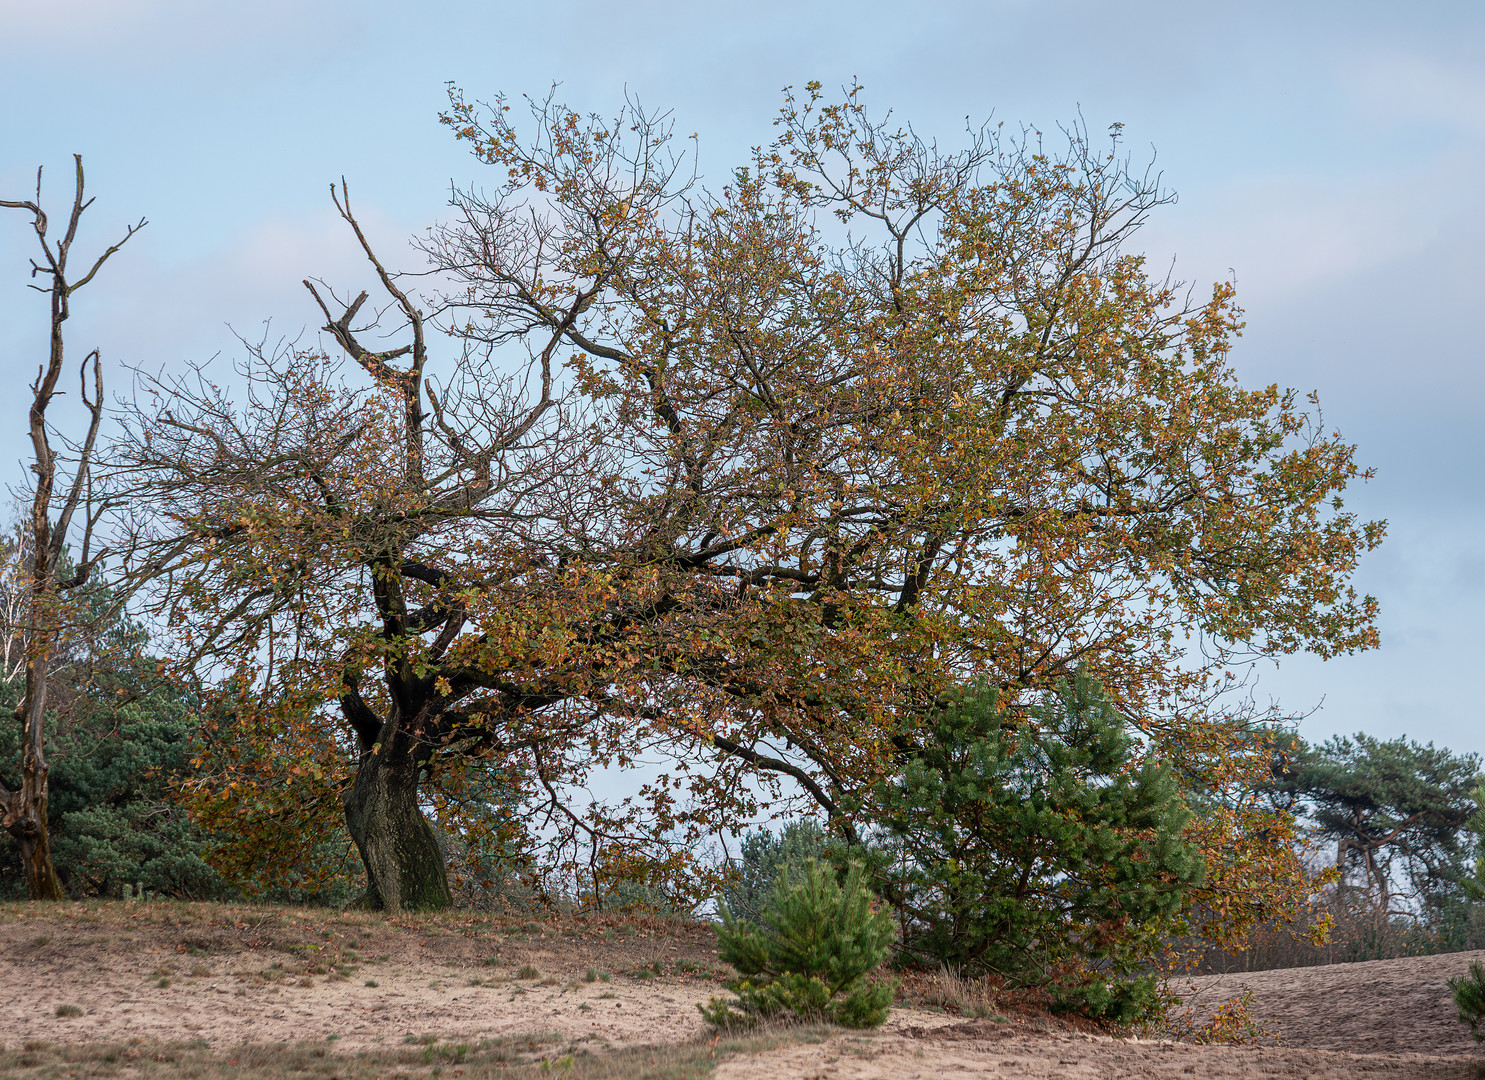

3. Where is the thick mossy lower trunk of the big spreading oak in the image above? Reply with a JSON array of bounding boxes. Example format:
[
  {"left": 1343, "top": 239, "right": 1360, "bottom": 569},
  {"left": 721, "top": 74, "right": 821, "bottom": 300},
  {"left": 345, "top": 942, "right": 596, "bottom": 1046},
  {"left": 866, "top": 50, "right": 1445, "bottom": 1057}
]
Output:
[{"left": 345, "top": 746, "right": 454, "bottom": 912}]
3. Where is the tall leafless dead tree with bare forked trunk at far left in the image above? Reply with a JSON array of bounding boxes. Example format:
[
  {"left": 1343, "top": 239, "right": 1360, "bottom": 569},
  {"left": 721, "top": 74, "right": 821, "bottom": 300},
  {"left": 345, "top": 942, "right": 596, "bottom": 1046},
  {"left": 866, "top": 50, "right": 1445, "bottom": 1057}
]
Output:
[{"left": 0, "top": 154, "right": 146, "bottom": 900}]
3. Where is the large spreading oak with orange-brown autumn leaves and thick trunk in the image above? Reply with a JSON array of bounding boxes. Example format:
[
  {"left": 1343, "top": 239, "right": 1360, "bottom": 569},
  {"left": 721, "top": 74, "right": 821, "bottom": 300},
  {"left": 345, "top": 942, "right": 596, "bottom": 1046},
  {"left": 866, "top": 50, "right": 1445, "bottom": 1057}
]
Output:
[{"left": 114, "top": 85, "right": 1381, "bottom": 928}]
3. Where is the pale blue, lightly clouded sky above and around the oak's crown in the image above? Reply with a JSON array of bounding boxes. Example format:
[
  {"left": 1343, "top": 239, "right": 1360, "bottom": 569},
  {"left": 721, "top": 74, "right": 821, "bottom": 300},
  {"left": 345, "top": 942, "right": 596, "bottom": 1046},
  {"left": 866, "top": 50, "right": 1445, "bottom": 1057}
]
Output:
[{"left": 0, "top": 0, "right": 1485, "bottom": 752}]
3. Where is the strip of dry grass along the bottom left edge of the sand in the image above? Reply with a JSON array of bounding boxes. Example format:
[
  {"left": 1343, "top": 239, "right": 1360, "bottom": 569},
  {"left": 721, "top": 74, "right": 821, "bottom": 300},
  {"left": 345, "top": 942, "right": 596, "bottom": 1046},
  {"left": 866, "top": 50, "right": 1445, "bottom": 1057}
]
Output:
[{"left": 0, "top": 1027, "right": 835, "bottom": 1080}]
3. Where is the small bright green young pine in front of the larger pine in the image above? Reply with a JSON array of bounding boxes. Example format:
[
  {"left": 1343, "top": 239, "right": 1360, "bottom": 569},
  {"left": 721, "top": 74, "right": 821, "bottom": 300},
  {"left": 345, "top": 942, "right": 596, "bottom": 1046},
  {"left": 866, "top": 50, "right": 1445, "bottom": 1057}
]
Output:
[{"left": 698, "top": 859, "right": 895, "bottom": 1028}]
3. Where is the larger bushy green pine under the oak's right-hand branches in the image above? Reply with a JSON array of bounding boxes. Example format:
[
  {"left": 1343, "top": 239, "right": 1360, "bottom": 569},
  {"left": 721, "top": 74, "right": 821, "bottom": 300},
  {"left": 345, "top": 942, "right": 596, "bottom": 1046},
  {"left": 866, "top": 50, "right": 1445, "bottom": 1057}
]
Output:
[{"left": 857, "top": 674, "right": 1204, "bottom": 1024}]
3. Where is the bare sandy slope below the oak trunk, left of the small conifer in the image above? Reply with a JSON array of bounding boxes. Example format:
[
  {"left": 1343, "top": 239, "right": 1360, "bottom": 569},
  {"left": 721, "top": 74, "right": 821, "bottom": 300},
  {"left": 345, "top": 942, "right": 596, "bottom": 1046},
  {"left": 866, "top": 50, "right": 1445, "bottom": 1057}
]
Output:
[{"left": 0, "top": 905, "right": 720, "bottom": 1050}]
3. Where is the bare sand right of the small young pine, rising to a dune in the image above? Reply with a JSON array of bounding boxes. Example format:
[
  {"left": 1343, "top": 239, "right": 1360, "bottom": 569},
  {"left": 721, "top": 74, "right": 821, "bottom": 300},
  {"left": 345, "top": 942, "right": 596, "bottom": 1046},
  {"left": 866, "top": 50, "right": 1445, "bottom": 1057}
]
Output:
[{"left": 716, "top": 952, "right": 1485, "bottom": 1080}]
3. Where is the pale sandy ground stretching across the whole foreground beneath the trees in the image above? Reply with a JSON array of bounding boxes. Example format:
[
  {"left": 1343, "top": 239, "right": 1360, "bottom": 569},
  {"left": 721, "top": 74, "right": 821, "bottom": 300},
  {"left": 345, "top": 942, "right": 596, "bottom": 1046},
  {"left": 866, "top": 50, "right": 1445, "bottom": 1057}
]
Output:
[{"left": 0, "top": 905, "right": 1485, "bottom": 1080}]
